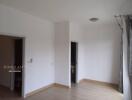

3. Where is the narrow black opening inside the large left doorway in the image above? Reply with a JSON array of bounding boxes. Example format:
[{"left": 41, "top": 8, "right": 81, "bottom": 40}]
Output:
[{"left": 14, "top": 39, "right": 23, "bottom": 95}]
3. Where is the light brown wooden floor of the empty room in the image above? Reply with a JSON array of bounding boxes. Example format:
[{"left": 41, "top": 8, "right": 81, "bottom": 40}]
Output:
[{"left": 0, "top": 82, "right": 123, "bottom": 100}]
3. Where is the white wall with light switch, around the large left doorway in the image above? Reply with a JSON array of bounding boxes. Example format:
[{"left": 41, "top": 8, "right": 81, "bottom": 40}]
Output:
[{"left": 0, "top": 5, "right": 54, "bottom": 94}]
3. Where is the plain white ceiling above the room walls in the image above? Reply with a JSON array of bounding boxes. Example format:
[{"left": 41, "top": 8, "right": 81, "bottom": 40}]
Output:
[{"left": 0, "top": 0, "right": 132, "bottom": 22}]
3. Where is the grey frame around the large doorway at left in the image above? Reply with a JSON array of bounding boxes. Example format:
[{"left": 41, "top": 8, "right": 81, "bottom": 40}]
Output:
[{"left": 0, "top": 33, "right": 26, "bottom": 98}]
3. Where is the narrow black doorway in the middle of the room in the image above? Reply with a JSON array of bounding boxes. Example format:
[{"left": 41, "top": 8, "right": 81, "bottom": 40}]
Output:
[{"left": 71, "top": 42, "right": 78, "bottom": 84}]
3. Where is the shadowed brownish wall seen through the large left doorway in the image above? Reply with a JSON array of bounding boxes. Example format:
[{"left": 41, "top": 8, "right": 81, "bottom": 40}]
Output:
[{"left": 0, "top": 36, "right": 14, "bottom": 88}]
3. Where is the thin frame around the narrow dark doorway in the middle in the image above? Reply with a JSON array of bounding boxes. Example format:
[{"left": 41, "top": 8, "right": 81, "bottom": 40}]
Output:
[{"left": 70, "top": 41, "right": 79, "bottom": 84}]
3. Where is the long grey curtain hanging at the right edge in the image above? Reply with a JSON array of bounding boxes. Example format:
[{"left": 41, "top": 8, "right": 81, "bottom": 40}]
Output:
[{"left": 120, "top": 15, "right": 132, "bottom": 100}]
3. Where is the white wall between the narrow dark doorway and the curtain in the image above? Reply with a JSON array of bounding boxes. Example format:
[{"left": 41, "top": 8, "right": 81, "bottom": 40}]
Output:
[{"left": 70, "top": 22, "right": 120, "bottom": 83}]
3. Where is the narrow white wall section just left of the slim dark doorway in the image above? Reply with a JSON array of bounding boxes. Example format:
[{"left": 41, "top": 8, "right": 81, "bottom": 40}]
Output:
[{"left": 55, "top": 22, "right": 70, "bottom": 86}]
